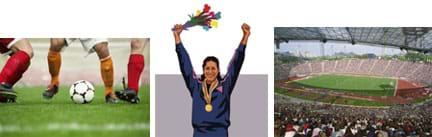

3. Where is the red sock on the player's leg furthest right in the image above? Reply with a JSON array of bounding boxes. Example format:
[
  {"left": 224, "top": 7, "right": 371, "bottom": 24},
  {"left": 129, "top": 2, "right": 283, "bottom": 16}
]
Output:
[{"left": 128, "top": 54, "right": 144, "bottom": 92}]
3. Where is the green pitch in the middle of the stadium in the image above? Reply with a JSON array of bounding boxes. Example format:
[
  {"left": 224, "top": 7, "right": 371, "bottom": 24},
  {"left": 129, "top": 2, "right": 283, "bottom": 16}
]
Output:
[{"left": 288, "top": 75, "right": 396, "bottom": 96}]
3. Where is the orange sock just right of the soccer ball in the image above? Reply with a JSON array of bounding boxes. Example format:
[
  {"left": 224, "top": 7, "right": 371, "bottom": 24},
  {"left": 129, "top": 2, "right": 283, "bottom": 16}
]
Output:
[{"left": 100, "top": 57, "right": 114, "bottom": 96}]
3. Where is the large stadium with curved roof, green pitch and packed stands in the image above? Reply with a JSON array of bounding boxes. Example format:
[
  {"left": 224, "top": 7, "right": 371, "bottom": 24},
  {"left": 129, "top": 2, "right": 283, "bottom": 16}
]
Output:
[{"left": 274, "top": 27, "right": 432, "bottom": 136}]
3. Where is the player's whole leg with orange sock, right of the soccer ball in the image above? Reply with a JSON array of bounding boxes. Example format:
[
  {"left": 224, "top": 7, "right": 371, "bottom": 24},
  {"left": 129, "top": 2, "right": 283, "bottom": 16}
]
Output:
[{"left": 94, "top": 42, "right": 117, "bottom": 103}]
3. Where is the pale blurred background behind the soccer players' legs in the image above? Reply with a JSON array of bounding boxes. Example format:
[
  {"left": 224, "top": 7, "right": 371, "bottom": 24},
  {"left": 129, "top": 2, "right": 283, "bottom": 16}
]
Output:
[{"left": 0, "top": 38, "right": 150, "bottom": 86}]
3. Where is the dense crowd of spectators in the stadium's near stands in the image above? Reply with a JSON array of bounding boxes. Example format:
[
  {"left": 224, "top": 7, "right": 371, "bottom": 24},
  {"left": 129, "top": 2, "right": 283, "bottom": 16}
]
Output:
[{"left": 274, "top": 97, "right": 432, "bottom": 137}]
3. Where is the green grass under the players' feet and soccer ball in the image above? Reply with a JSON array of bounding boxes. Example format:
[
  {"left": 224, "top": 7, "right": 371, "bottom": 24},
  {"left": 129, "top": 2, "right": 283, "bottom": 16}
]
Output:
[{"left": 0, "top": 86, "right": 150, "bottom": 137}]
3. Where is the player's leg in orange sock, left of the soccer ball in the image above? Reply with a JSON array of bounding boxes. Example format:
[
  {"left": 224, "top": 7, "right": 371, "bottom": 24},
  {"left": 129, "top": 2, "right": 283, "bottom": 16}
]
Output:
[{"left": 42, "top": 38, "right": 67, "bottom": 99}]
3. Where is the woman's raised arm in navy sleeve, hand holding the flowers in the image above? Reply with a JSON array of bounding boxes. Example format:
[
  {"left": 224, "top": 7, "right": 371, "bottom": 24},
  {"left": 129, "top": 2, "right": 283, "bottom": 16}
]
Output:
[{"left": 173, "top": 24, "right": 198, "bottom": 96}]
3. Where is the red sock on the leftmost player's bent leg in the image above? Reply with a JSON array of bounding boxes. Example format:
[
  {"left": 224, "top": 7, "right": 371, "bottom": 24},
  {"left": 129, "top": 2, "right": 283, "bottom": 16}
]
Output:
[{"left": 0, "top": 51, "right": 30, "bottom": 85}]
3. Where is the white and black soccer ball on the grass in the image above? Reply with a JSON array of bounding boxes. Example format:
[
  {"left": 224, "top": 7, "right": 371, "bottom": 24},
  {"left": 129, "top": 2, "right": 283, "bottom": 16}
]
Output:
[{"left": 69, "top": 80, "right": 94, "bottom": 104}]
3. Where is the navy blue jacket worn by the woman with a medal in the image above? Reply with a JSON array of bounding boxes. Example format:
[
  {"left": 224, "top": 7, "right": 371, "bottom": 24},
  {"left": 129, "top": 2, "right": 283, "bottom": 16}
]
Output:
[{"left": 176, "top": 43, "right": 246, "bottom": 128}]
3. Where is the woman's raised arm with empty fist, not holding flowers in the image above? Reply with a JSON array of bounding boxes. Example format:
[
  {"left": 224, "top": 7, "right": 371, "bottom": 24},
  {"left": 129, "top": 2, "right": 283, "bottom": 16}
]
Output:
[{"left": 223, "top": 23, "right": 250, "bottom": 94}]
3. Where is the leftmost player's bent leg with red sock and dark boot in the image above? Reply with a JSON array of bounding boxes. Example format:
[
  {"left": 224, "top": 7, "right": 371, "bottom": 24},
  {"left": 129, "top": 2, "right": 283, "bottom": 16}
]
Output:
[{"left": 0, "top": 39, "right": 33, "bottom": 98}]
